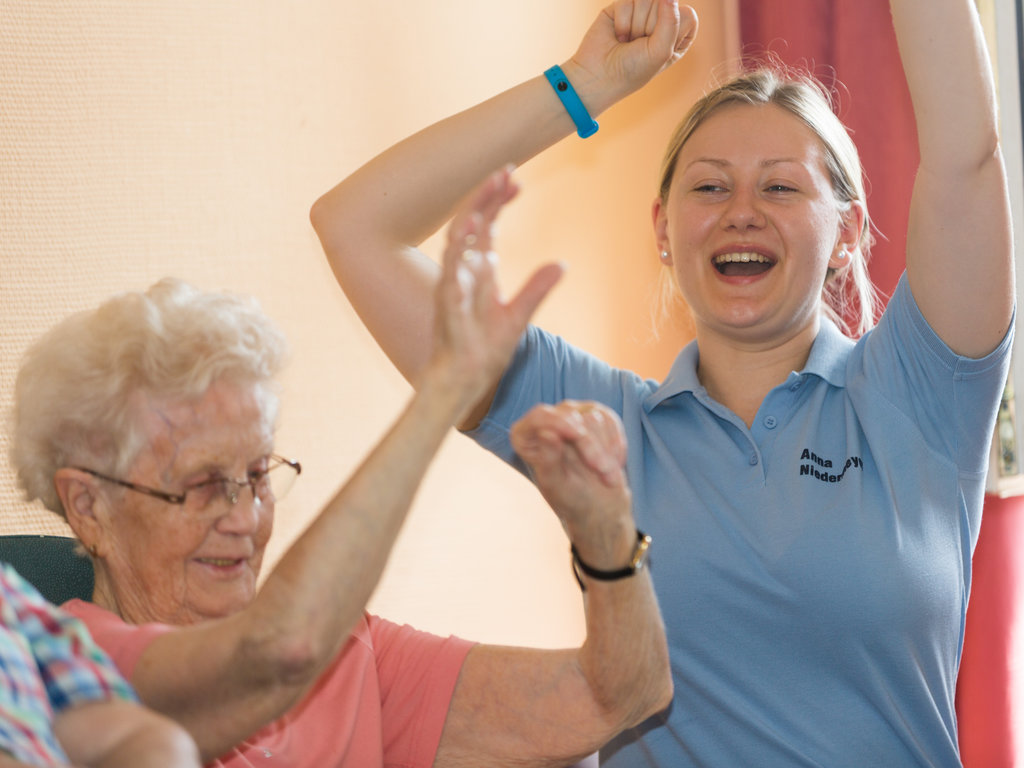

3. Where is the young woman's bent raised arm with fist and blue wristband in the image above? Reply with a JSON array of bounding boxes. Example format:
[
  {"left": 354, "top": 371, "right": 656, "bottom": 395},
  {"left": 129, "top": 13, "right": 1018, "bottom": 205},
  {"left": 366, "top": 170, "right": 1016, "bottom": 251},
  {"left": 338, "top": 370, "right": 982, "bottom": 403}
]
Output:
[{"left": 310, "top": 0, "right": 696, "bottom": 415}]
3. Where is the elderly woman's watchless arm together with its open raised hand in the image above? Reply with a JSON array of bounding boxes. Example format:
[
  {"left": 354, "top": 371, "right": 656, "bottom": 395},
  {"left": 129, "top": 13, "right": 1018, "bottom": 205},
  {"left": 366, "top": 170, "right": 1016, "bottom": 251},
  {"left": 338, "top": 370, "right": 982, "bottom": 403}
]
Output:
[{"left": 125, "top": 179, "right": 561, "bottom": 761}]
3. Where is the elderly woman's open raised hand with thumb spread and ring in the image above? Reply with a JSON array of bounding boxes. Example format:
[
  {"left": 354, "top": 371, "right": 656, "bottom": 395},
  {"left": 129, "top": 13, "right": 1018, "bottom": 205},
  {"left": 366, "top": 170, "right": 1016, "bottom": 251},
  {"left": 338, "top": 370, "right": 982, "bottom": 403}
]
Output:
[{"left": 429, "top": 168, "right": 562, "bottom": 421}]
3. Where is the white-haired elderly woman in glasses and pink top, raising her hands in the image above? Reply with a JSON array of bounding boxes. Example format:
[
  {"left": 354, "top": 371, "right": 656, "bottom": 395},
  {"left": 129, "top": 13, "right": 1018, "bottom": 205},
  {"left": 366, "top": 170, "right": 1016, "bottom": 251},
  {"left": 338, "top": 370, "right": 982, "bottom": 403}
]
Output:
[{"left": 13, "top": 201, "right": 671, "bottom": 768}]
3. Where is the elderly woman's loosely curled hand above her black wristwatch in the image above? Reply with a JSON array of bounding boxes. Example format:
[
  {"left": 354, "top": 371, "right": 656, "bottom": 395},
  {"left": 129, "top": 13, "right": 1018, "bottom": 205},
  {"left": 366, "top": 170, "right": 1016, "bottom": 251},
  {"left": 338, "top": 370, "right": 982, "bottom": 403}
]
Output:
[{"left": 510, "top": 400, "right": 633, "bottom": 551}]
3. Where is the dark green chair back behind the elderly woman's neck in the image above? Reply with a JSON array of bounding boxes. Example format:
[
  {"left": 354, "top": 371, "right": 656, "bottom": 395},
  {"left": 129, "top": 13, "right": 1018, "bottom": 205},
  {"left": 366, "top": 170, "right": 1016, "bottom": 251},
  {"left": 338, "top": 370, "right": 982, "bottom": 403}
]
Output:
[{"left": 0, "top": 535, "right": 94, "bottom": 605}]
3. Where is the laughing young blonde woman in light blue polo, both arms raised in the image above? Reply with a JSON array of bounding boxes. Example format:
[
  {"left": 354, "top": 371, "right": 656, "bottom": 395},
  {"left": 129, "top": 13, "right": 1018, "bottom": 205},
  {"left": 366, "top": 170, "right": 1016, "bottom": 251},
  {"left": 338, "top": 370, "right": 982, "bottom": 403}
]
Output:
[{"left": 312, "top": 0, "right": 1014, "bottom": 768}]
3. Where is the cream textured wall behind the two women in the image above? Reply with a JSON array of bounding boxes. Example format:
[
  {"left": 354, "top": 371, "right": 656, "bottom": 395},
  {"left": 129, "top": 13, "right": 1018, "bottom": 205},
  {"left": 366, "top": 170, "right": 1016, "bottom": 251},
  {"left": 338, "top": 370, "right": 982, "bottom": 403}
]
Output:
[{"left": 0, "top": 0, "right": 730, "bottom": 645}]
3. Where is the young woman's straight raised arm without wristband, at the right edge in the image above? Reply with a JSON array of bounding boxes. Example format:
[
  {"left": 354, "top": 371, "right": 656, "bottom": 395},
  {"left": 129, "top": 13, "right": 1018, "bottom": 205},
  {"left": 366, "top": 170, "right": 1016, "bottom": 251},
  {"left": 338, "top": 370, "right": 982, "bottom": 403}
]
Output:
[{"left": 891, "top": 0, "right": 1014, "bottom": 357}]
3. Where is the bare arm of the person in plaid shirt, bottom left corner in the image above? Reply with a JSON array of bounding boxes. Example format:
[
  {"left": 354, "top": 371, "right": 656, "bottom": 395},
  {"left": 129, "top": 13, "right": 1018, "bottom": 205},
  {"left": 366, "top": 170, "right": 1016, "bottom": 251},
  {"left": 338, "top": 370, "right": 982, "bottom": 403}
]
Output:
[{"left": 52, "top": 699, "right": 200, "bottom": 768}]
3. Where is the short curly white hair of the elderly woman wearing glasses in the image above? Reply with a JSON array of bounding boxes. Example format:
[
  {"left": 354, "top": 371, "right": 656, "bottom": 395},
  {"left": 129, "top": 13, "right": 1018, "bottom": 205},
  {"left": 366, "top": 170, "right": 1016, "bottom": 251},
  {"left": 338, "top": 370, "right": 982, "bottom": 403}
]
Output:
[{"left": 10, "top": 279, "right": 287, "bottom": 515}]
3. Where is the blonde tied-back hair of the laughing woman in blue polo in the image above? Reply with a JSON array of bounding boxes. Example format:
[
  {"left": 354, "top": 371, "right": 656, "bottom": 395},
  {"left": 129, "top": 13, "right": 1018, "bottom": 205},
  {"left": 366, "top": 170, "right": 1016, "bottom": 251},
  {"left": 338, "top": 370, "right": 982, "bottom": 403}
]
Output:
[{"left": 658, "top": 61, "right": 881, "bottom": 337}]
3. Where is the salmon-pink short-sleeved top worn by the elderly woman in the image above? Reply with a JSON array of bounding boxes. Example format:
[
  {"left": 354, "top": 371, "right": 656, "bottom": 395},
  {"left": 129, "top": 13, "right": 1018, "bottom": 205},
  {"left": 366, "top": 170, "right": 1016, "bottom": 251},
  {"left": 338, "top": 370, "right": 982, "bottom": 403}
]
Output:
[{"left": 63, "top": 600, "right": 472, "bottom": 768}]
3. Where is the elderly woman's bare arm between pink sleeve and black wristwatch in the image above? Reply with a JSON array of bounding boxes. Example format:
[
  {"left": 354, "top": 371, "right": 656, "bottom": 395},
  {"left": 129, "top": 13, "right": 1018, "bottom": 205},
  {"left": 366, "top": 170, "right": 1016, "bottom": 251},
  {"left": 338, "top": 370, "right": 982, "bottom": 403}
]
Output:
[{"left": 434, "top": 561, "right": 672, "bottom": 768}]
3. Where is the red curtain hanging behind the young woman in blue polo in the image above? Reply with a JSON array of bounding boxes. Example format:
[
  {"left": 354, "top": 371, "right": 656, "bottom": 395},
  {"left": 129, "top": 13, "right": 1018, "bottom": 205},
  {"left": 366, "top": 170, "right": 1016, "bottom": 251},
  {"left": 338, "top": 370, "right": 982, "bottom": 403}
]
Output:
[{"left": 738, "top": 0, "right": 1024, "bottom": 768}]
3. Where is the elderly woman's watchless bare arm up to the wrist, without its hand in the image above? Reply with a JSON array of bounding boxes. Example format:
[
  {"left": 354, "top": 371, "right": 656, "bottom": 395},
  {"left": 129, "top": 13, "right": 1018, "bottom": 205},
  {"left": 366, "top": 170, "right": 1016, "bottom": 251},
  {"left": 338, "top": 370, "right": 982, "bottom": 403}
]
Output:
[{"left": 131, "top": 376, "right": 497, "bottom": 762}]
